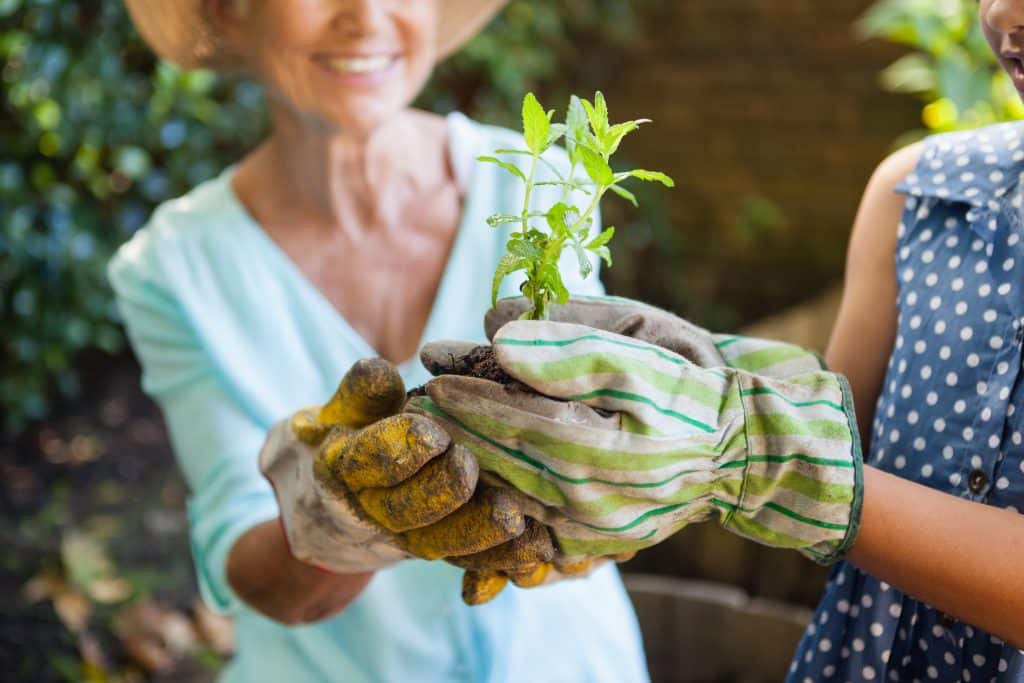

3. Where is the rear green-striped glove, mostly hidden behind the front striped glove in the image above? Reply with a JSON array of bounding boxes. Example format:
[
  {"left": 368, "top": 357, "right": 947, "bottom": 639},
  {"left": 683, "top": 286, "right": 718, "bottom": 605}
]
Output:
[{"left": 483, "top": 296, "right": 826, "bottom": 377}]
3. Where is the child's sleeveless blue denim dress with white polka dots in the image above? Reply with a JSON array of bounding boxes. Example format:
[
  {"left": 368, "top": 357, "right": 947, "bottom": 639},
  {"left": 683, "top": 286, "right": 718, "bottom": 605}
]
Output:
[{"left": 787, "top": 123, "right": 1024, "bottom": 683}]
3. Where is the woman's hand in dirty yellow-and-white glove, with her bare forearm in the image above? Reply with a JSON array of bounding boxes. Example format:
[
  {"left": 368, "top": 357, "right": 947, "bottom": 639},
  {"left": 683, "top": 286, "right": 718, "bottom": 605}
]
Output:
[{"left": 238, "top": 359, "right": 554, "bottom": 624}]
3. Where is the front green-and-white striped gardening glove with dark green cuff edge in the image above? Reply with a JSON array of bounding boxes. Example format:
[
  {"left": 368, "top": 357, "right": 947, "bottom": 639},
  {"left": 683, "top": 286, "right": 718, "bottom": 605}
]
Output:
[{"left": 418, "top": 321, "right": 862, "bottom": 563}]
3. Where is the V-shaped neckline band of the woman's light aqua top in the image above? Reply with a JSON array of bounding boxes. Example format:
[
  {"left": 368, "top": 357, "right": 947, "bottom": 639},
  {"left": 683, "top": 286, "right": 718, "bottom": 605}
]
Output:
[{"left": 219, "top": 114, "right": 479, "bottom": 376}]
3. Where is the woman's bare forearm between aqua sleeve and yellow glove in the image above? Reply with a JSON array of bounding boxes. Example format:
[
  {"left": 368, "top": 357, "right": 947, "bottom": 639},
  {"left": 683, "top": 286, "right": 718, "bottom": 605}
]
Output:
[{"left": 227, "top": 519, "right": 374, "bottom": 626}]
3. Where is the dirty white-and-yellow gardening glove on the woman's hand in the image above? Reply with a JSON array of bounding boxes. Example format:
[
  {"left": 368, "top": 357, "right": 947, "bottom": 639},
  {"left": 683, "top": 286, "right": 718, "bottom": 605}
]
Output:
[{"left": 260, "top": 358, "right": 532, "bottom": 572}]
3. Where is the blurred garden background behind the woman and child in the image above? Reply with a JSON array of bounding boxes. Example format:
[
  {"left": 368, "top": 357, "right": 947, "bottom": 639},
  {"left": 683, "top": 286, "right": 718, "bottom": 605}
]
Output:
[{"left": 0, "top": 0, "right": 1024, "bottom": 681}]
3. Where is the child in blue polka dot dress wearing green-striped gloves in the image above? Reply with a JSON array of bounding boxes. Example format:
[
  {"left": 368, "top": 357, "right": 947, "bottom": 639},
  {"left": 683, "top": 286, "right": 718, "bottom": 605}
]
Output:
[{"left": 419, "top": 0, "right": 1024, "bottom": 682}]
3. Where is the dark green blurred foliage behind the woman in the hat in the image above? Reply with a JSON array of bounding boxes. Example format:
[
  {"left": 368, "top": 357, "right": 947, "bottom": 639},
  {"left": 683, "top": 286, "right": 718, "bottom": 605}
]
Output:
[{"left": 0, "top": 0, "right": 634, "bottom": 433}]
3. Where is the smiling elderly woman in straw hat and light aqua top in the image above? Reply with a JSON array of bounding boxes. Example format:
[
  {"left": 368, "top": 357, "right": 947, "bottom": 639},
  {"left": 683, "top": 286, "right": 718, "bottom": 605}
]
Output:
[{"left": 110, "top": 0, "right": 647, "bottom": 682}]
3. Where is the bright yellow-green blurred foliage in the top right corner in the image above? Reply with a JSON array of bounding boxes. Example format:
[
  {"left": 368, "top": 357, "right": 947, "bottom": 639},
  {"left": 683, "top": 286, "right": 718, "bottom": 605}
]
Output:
[{"left": 857, "top": 0, "right": 1024, "bottom": 142}]
